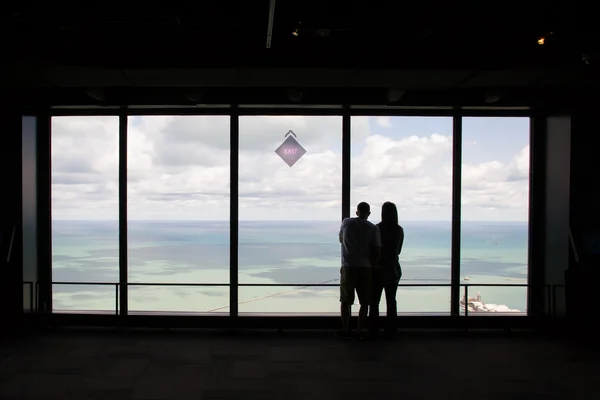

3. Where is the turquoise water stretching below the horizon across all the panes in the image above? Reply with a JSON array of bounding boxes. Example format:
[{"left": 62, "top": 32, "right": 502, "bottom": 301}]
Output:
[{"left": 52, "top": 221, "right": 528, "bottom": 313}]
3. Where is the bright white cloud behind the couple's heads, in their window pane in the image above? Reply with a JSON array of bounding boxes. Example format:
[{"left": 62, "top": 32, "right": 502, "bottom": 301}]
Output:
[{"left": 351, "top": 133, "right": 452, "bottom": 220}]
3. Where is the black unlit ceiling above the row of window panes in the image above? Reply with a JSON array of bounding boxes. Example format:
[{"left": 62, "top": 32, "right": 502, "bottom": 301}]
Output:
[{"left": 0, "top": 0, "right": 600, "bottom": 108}]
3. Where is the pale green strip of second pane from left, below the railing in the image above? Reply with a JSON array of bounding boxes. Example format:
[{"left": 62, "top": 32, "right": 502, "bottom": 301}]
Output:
[{"left": 129, "top": 285, "right": 229, "bottom": 315}]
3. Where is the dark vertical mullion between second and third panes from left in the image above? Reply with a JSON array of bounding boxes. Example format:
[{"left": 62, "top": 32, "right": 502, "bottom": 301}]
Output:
[{"left": 229, "top": 106, "right": 240, "bottom": 321}]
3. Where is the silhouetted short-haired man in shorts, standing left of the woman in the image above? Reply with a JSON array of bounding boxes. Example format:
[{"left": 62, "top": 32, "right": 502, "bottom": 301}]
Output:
[{"left": 339, "top": 202, "right": 381, "bottom": 338}]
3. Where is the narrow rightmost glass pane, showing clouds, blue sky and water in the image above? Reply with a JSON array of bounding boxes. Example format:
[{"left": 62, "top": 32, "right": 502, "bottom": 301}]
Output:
[{"left": 461, "top": 118, "right": 529, "bottom": 312}]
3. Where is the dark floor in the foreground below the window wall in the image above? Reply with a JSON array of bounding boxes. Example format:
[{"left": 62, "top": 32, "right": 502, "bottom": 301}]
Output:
[{"left": 0, "top": 332, "right": 600, "bottom": 400}]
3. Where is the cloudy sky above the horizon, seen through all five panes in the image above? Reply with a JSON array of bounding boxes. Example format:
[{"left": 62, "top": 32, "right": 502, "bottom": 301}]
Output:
[{"left": 52, "top": 116, "right": 529, "bottom": 222}]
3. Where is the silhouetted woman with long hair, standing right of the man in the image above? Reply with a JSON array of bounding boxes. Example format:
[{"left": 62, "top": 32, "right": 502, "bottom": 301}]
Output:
[{"left": 369, "top": 201, "right": 404, "bottom": 338}]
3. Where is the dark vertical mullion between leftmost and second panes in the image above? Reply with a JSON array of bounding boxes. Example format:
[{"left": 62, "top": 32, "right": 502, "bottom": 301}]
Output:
[{"left": 119, "top": 110, "right": 129, "bottom": 315}]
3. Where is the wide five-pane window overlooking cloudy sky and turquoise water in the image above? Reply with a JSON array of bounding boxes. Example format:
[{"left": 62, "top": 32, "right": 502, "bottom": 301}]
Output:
[{"left": 51, "top": 111, "right": 530, "bottom": 315}]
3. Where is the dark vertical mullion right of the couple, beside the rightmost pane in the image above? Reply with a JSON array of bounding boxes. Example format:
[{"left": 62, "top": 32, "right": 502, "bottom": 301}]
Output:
[{"left": 450, "top": 115, "right": 462, "bottom": 315}]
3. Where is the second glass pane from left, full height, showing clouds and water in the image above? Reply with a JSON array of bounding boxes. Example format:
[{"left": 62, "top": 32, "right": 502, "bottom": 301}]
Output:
[{"left": 127, "top": 116, "right": 230, "bottom": 312}]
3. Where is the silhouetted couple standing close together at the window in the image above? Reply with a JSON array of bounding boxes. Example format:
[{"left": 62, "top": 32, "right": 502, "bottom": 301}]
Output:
[{"left": 339, "top": 201, "right": 404, "bottom": 339}]
